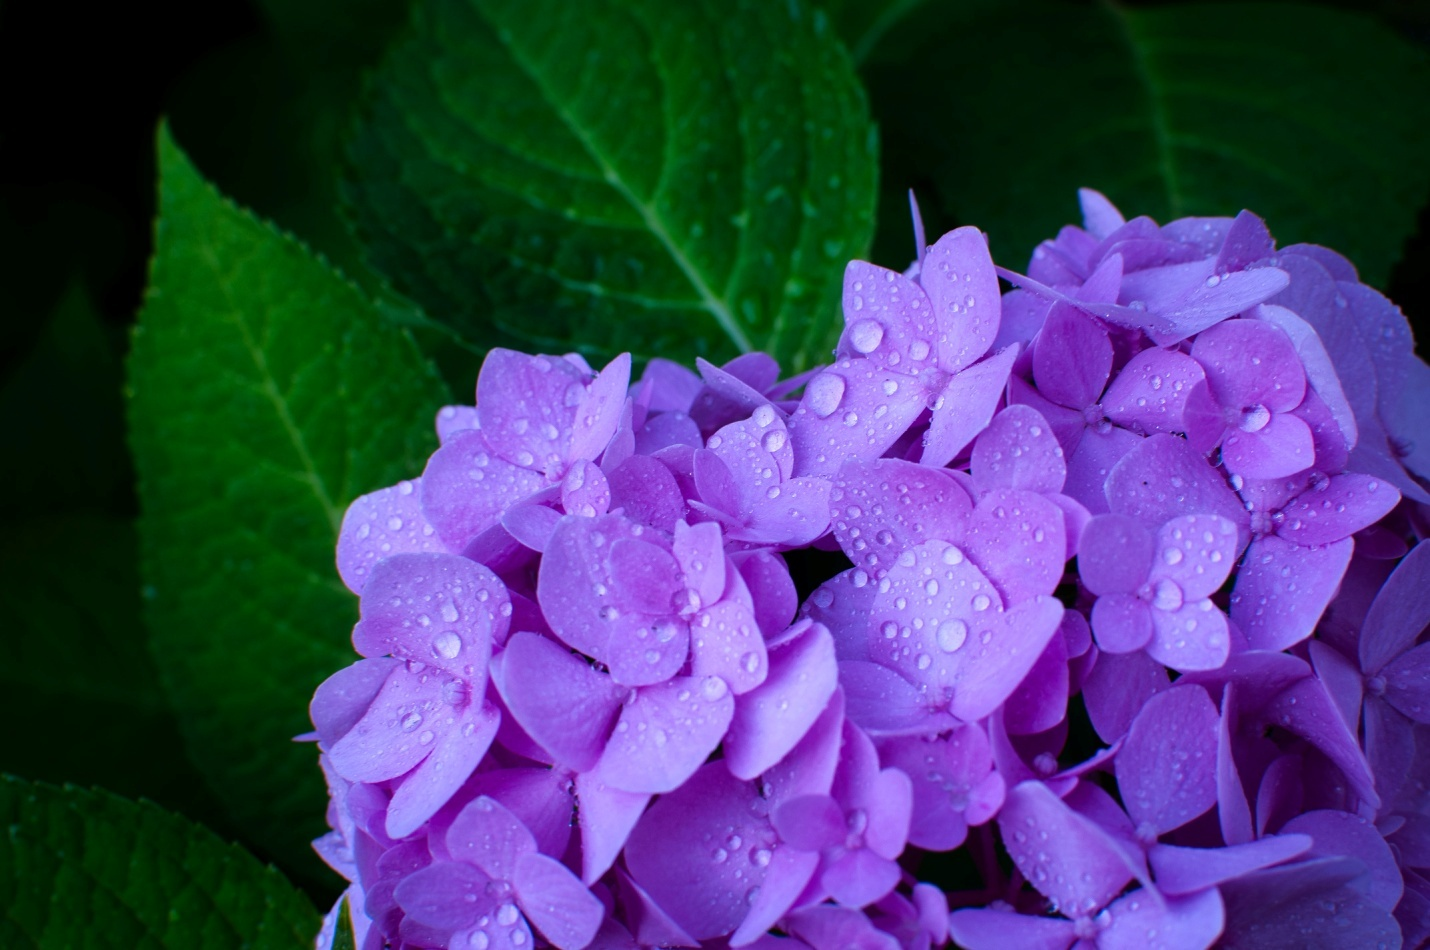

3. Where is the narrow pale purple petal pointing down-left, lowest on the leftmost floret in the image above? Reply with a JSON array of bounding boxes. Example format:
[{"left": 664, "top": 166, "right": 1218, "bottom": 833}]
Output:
[{"left": 386, "top": 702, "right": 502, "bottom": 838}]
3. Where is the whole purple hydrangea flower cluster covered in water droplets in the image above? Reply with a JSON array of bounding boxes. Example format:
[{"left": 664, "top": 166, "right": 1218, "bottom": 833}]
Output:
[{"left": 312, "top": 192, "right": 1430, "bottom": 950}]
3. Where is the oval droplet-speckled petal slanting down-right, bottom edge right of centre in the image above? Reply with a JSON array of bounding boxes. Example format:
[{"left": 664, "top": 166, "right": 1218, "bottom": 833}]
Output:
[{"left": 998, "top": 781, "right": 1133, "bottom": 916}]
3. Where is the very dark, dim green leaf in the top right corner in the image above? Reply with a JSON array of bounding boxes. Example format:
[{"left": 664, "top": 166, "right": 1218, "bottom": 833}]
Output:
[{"left": 865, "top": 0, "right": 1430, "bottom": 285}]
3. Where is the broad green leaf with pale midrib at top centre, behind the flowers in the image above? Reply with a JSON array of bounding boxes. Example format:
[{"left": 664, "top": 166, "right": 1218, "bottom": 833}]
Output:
[{"left": 347, "top": 0, "right": 877, "bottom": 369}]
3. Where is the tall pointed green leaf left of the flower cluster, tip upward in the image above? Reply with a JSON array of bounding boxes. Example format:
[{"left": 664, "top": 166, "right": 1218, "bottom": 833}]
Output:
[{"left": 129, "top": 130, "right": 446, "bottom": 873}]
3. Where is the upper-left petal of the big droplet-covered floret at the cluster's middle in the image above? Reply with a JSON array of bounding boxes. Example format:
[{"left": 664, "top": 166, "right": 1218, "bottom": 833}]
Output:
[{"left": 829, "top": 459, "right": 972, "bottom": 571}]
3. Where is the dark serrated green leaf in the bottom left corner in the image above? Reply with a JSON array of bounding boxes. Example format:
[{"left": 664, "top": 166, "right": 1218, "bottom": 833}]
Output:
[{"left": 0, "top": 775, "right": 319, "bottom": 950}]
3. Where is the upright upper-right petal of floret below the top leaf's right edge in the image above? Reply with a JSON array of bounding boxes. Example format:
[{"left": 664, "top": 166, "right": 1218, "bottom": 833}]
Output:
[{"left": 919, "top": 227, "right": 1000, "bottom": 372}]
